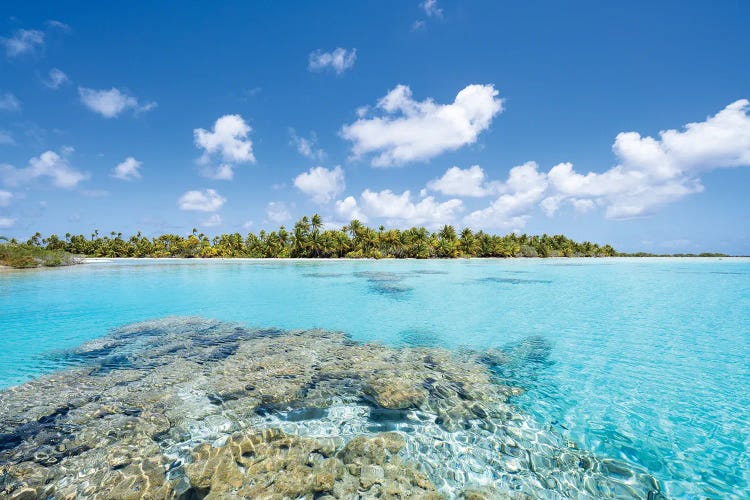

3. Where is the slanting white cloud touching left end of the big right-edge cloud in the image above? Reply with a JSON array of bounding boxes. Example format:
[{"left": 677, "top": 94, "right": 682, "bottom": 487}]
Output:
[{"left": 464, "top": 161, "right": 547, "bottom": 230}]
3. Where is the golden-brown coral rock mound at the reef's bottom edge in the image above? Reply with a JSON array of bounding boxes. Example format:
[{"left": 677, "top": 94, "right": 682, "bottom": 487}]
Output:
[{"left": 187, "top": 429, "right": 441, "bottom": 498}]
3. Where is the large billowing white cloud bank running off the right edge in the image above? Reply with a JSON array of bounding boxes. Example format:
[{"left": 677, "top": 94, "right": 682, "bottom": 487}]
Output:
[{"left": 545, "top": 99, "right": 750, "bottom": 219}]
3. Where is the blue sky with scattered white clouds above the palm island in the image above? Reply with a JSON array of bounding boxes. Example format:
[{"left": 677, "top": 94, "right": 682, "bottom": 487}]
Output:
[{"left": 0, "top": 0, "right": 750, "bottom": 255}]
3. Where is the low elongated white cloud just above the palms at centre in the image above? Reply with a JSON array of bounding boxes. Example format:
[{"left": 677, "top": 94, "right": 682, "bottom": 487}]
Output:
[{"left": 336, "top": 189, "right": 463, "bottom": 227}]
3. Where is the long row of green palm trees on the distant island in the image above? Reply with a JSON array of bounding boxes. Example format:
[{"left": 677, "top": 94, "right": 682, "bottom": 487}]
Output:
[{"left": 11, "top": 214, "right": 617, "bottom": 259}]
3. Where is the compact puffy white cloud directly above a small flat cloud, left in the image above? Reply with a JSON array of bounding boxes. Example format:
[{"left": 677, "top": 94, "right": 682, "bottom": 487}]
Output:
[{"left": 193, "top": 115, "right": 255, "bottom": 180}]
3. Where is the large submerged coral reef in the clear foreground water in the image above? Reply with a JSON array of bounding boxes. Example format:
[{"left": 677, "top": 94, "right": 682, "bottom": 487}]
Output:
[{"left": 0, "top": 318, "right": 658, "bottom": 498}]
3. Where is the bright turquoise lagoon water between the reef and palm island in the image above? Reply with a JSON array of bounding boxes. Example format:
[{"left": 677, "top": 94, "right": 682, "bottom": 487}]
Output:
[{"left": 0, "top": 259, "right": 750, "bottom": 498}]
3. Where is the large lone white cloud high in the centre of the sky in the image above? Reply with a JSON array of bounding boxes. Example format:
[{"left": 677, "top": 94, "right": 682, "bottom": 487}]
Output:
[{"left": 341, "top": 85, "right": 503, "bottom": 167}]
